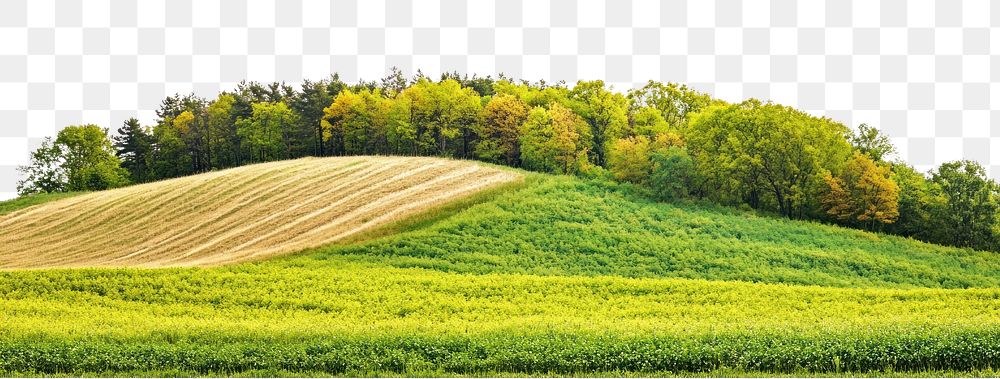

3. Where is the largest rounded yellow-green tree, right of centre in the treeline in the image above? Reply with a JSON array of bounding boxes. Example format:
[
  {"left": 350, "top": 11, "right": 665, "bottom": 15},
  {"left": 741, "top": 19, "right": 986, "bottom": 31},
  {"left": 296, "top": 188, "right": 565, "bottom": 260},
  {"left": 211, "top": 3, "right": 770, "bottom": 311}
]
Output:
[{"left": 684, "top": 100, "right": 851, "bottom": 217}]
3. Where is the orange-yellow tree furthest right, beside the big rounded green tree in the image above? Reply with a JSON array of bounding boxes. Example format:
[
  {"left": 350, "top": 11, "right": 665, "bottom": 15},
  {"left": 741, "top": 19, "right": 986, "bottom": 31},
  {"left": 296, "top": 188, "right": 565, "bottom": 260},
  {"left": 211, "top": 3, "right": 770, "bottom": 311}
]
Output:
[{"left": 821, "top": 152, "right": 899, "bottom": 229}]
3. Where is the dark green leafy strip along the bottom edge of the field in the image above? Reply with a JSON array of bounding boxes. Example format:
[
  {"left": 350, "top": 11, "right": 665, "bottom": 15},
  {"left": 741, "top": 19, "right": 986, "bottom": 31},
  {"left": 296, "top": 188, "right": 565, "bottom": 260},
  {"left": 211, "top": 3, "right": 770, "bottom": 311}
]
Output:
[{"left": 0, "top": 329, "right": 1000, "bottom": 375}]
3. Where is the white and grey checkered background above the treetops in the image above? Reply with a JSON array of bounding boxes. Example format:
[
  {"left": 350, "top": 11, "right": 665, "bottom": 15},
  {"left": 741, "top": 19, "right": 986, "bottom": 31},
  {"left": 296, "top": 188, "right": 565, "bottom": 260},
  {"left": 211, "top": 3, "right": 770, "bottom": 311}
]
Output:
[{"left": 0, "top": 0, "right": 1000, "bottom": 198}]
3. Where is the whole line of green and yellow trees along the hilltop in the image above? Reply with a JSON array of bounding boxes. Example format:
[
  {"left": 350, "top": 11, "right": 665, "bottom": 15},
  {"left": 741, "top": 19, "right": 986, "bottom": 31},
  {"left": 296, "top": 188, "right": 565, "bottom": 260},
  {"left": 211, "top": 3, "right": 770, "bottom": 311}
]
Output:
[{"left": 18, "top": 70, "right": 1000, "bottom": 254}]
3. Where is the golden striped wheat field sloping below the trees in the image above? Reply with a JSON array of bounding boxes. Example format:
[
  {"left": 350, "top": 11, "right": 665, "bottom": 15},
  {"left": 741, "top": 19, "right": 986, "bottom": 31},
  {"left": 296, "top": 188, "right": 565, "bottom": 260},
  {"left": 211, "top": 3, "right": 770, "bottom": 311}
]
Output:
[{"left": 0, "top": 157, "right": 520, "bottom": 269}]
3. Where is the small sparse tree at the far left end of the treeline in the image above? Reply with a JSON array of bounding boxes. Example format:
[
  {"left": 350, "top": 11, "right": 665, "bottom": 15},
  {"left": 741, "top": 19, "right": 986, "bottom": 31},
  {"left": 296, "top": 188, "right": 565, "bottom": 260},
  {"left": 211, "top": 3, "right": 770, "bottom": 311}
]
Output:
[{"left": 17, "top": 137, "right": 69, "bottom": 196}]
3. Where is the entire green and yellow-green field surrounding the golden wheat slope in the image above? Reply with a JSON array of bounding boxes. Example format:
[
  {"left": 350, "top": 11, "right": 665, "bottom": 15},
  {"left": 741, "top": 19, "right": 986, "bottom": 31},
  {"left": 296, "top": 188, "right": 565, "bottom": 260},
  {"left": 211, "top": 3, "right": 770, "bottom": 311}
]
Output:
[{"left": 0, "top": 173, "right": 1000, "bottom": 376}]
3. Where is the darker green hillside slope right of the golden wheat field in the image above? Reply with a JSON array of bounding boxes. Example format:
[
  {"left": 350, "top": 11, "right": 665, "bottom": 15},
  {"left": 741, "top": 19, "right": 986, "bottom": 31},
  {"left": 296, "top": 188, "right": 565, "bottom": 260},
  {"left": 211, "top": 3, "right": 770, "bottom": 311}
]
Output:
[{"left": 316, "top": 174, "right": 1000, "bottom": 288}]
